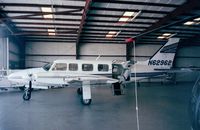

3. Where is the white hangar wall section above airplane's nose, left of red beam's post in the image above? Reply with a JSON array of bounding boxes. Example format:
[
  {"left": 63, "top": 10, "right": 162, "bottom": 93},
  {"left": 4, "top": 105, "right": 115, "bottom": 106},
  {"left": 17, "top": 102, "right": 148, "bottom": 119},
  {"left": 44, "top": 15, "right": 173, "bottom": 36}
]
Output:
[{"left": 25, "top": 42, "right": 76, "bottom": 68}]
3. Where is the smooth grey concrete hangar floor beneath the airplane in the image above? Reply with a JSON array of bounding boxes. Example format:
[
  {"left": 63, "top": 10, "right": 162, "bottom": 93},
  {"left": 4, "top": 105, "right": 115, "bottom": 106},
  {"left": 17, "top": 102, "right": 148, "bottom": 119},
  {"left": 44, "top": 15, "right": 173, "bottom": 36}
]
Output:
[{"left": 0, "top": 83, "right": 193, "bottom": 130}]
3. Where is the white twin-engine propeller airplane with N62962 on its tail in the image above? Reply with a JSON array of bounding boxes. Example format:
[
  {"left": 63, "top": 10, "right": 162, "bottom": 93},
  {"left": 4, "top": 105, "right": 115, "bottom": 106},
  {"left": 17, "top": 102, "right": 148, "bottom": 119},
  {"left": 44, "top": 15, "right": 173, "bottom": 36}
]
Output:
[{"left": 8, "top": 38, "right": 179, "bottom": 105}]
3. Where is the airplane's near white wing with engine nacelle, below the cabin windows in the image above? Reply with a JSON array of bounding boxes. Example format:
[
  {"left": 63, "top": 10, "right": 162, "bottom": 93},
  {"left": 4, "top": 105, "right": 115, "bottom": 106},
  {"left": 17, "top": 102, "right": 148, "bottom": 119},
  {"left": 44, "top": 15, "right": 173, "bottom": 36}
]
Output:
[{"left": 29, "top": 72, "right": 118, "bottom": 88}]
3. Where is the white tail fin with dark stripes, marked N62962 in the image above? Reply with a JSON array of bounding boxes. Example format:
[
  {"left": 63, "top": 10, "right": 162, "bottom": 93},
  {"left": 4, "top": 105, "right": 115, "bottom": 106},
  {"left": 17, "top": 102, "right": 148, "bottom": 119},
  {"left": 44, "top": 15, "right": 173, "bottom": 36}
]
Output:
[{"left": 148, "top": 38, "right": 180, "bottom": 69}]
